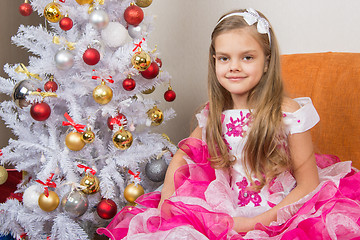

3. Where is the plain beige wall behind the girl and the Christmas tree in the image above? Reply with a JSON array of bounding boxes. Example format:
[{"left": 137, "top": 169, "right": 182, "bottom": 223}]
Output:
[{"left": 0, "top": 0, "right": 360, "bottom": 147}]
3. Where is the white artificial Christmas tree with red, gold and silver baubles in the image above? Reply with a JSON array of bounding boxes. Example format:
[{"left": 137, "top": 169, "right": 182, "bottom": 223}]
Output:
[{"left": 0, "top": 0, "right": 176, "bottom": 239}]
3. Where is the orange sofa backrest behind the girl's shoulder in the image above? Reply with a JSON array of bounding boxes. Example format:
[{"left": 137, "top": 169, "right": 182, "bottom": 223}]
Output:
[{"left": 281, "top": 52, "right": 360, "bottom": 169}]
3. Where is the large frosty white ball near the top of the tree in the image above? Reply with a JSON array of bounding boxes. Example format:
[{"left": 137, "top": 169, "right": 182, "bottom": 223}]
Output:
[{"left": 101, "top": 22, "right": 128, "bottom": 47}]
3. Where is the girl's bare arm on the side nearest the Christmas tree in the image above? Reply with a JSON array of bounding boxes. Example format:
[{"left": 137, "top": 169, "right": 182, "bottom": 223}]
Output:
[{"left": 159, "top": 127, "right": 202, "bottom": 208}]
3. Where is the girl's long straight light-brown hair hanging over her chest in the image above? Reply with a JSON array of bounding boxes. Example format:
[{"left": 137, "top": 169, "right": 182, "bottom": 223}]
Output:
[{"left": 206, "top": 10, "right": 290, "bottom": 189}]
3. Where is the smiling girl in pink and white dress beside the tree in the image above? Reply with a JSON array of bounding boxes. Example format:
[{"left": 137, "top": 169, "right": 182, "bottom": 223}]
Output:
[{"left": 98, "top": 9, "right": 360, "bottom": 239}]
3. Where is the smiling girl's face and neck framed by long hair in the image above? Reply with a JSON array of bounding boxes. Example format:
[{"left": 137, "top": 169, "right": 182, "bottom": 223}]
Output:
[{"left": 214, "top": 29, "right": 268, "bottom": 109}]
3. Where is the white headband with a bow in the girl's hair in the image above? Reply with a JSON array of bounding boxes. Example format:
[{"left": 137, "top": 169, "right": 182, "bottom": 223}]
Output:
[{"left": 216, "top": 8, "right": 271, "bottom": 45}]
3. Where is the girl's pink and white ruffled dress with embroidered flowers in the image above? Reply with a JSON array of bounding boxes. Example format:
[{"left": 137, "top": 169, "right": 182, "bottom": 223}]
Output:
[{"left": 97, "top": 98, "right": 360, "bottom": 240}]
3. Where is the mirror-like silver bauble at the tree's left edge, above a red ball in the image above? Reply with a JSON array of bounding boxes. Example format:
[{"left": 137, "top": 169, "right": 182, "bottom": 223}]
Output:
[{"left": 11, "top": 80, "right": 36, "bottom": 108}]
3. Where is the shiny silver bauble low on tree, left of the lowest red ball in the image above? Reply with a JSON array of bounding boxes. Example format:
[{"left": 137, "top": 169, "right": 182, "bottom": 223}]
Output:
[{"left": 61, "top": 190, "right": 89, "bottom": 218}]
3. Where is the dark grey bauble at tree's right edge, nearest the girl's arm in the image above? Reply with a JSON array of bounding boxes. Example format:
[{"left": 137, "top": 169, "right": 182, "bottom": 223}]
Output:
[{"left": 145, "top": 158, "right": 168, "bottom": 182}]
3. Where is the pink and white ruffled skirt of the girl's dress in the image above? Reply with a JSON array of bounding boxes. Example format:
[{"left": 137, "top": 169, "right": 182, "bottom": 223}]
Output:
[{"left": 97, "top": 138, "right": 360, "bottom": 240}]
